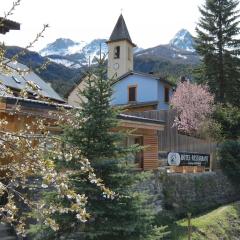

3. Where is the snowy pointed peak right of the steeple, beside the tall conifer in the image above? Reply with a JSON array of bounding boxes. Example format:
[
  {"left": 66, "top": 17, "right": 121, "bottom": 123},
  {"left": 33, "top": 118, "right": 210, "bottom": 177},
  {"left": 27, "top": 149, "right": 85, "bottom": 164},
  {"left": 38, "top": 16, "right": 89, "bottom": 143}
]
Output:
[{"left": 169, "top": 29, "right": 195, "bottom": 52}]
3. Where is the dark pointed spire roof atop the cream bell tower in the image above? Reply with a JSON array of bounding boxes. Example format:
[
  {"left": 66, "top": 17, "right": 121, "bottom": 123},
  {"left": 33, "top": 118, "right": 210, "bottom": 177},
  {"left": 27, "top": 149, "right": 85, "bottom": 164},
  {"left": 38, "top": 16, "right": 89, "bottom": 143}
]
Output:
[{"left": 108, "top": 14, "right": 136, "bottom": 46}]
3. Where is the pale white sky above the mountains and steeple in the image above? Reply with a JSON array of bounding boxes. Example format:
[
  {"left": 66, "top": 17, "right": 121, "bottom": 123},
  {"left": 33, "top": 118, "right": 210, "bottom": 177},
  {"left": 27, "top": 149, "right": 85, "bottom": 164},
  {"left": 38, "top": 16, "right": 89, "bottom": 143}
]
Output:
[{"left": 0, "top": 0, "right": 204, "bottom": 50}]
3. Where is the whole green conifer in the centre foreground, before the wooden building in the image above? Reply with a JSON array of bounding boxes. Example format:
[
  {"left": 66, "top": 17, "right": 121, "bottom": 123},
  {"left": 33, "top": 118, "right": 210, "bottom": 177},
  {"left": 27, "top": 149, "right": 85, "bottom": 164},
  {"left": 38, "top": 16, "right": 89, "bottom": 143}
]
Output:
[{"left": 36, "top": 59, "right": 169, "bottom": 240}]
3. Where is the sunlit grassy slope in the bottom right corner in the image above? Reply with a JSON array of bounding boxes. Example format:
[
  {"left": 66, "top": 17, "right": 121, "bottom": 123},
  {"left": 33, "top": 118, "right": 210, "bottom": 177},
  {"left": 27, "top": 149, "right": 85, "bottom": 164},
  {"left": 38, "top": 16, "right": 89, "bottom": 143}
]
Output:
[{"left": 168, "top": 202, "right": 240, "bottom": 240}]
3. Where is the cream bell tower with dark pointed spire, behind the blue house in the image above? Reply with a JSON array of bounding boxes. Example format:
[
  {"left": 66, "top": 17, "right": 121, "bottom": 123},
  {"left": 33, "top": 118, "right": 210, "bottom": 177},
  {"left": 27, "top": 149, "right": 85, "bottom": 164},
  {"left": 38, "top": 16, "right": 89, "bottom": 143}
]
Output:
[{"left": 107, "top": 14, "right": 136, "bottom": 78}]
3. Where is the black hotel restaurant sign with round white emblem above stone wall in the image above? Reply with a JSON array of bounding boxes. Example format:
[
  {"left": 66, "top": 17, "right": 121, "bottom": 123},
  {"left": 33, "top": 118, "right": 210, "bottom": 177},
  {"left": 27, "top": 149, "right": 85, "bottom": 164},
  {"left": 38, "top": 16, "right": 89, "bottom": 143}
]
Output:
[{"left": 167, "top": 152, "right": 210, "bottom": 167}]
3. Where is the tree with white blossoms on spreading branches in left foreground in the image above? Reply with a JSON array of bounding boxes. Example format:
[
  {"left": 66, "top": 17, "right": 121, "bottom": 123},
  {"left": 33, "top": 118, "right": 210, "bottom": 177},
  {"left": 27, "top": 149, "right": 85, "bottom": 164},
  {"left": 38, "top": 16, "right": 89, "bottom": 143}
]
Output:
[{"left": 0, "top": 0, "right": 114, "bottom": 235}]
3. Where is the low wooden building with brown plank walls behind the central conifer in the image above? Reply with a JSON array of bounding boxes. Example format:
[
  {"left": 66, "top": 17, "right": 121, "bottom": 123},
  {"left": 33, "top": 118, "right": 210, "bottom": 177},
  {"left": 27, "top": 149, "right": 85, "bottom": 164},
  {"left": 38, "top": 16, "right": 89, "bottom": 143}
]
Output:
[{"left": 0, "top": 97, "right": 164, "bottom": 170}]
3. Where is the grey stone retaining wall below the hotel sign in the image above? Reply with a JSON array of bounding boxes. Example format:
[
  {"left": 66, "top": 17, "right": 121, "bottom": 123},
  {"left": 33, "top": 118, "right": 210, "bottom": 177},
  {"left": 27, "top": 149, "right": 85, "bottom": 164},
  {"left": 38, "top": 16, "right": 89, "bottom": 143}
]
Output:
[{"left": 142, "top": 171, "right": 240, "bottom": 216}]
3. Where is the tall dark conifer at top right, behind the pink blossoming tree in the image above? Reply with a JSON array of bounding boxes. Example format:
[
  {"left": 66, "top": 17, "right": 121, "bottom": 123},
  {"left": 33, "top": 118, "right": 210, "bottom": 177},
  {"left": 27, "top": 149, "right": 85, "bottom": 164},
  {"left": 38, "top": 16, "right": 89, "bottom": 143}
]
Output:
[{"left": 195, "top": 0, "right": 240, "bottom": 105}]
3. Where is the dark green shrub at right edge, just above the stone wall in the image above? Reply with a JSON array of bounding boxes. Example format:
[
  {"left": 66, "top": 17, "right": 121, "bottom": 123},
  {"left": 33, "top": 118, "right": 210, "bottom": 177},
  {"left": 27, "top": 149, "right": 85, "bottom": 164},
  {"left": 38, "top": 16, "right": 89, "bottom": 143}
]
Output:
[{"left": 219, "top": 140, "right": 240, "bottom": 183}]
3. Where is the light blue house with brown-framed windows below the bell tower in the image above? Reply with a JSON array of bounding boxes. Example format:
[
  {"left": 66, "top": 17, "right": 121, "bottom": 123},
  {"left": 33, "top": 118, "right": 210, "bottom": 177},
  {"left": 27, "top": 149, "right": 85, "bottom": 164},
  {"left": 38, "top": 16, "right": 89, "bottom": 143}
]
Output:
[{"left": 112, "top": 71, "right": 173, "bottom": 112}]
